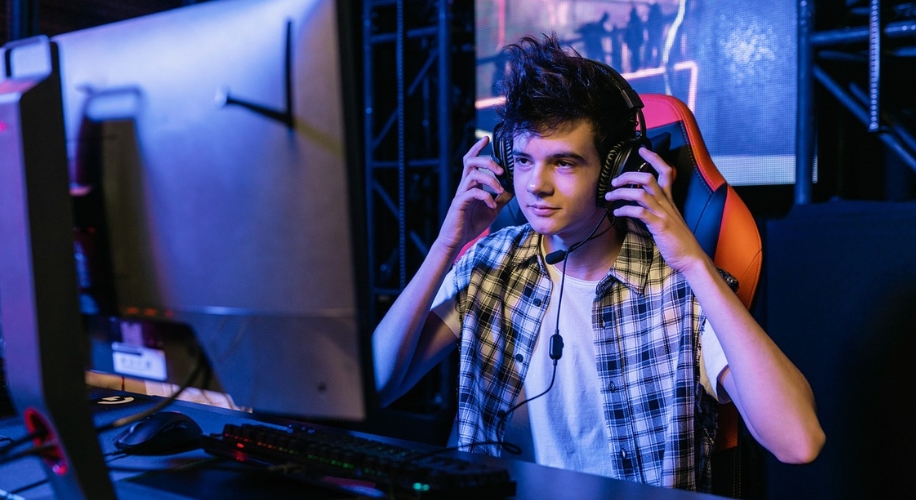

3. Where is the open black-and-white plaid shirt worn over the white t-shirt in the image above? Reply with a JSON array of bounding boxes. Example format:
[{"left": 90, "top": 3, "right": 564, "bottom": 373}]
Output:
[{"left": 455, "top": 222, "right": 716, "bottom": 490}]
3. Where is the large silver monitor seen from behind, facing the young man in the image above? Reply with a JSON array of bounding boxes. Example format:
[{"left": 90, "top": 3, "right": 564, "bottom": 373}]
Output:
[{"left": 54, "top": 0, "right": 374, "bottom": 421}]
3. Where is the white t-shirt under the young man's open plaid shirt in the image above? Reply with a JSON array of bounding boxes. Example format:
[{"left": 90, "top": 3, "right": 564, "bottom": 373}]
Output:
[{"left": 433, "top": 263, "right": 727, "bottom": 476}]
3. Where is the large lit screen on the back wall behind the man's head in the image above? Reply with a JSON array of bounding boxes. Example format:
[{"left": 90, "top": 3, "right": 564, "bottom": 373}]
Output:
[{"left": 475, "top": 0, "right": 797, "bottom": 186}]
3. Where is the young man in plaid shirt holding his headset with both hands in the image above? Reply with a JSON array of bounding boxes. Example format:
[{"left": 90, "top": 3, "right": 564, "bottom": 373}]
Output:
[{"left": 373, "top": 37, "right": 824, "bottom": 490}]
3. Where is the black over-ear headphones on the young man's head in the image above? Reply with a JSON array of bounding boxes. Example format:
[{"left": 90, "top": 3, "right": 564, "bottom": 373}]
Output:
[{"left": 493, "top": 59, "right": 652, "bottom": 208}]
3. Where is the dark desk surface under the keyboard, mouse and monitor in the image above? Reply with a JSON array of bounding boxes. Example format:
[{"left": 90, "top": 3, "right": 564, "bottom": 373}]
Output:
[{"left": 0, "top": 391, "right": 720, "bottom": 500}]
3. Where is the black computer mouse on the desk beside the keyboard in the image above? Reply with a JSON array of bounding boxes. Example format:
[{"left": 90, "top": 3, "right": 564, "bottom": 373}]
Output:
[{"left": 115, "top": 411, "right": 202, "bottom": 455}]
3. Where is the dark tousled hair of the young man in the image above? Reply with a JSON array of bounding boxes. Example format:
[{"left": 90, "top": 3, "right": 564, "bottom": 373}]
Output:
[{"left": 496, "top": 34, "right": 636, "bottom": 157}]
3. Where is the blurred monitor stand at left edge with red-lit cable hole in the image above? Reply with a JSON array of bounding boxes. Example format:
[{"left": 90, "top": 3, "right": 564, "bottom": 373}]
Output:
[{"left": 0, "top": 37, "right": 115, "bottom": 500}]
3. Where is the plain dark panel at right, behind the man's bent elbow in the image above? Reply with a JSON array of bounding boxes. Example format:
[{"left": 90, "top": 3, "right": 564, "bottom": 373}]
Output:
[{"left": 764, "top": 200, "right": 916, "bottom": 499}]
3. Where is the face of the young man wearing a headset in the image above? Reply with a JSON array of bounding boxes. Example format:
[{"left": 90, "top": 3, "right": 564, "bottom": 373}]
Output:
[{"left": 512, "top": 120, "right": 605, "bottom": 244}]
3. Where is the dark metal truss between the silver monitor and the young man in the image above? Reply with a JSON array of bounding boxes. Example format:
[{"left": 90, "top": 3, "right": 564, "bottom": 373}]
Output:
[{"left": 362, "top": 0, "right": 474, "bottom": 420}]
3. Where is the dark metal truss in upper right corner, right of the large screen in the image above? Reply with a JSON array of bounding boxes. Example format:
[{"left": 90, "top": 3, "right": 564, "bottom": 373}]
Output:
[{"left": 795, "top": 0, "right": 916, "bottom": 204}]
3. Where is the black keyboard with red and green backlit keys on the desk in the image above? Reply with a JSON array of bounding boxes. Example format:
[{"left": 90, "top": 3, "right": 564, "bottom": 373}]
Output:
[{"left": 202, "top": 424, "right": 516, "bottom": 500}]
